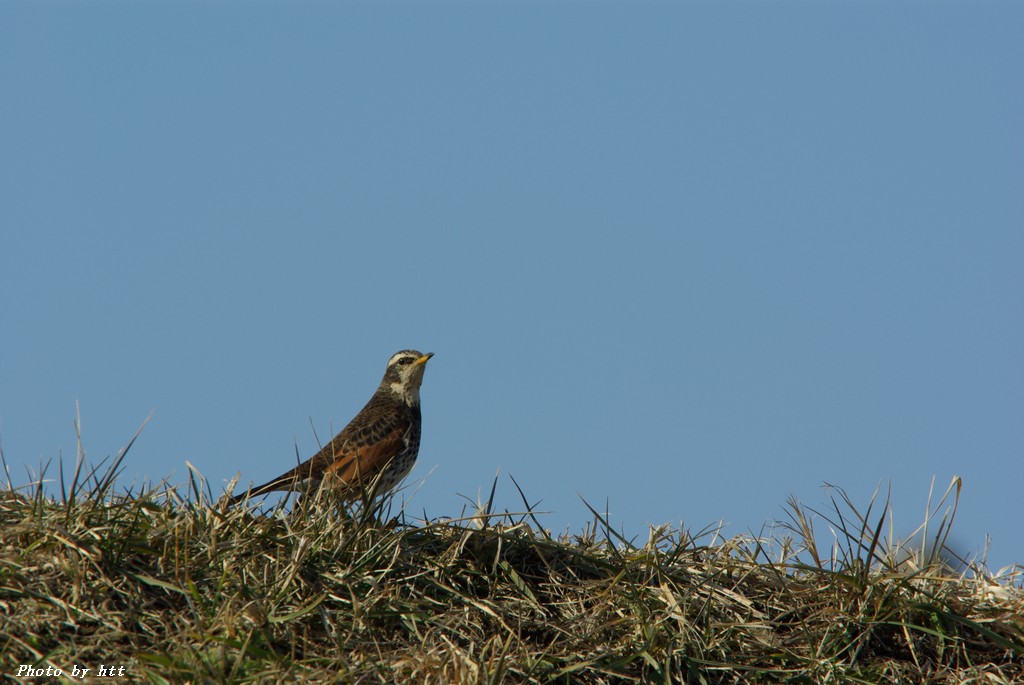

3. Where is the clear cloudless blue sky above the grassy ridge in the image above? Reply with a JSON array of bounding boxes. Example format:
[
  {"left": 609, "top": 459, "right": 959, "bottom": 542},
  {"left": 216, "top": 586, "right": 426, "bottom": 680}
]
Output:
[{"left": 0, "top": 2, "right": 1024, "bottom": 568}]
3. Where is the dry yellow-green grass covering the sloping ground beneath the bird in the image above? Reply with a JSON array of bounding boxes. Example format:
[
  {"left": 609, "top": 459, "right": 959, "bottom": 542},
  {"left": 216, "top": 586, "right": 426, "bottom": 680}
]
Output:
[{"left": 0, "top": 430, "right": 1024, "bottom": 685}]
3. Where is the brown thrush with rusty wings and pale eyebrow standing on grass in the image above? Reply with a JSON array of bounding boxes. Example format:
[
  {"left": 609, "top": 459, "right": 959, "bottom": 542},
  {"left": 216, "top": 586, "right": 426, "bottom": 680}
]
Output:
[{"left": 228, "top": 349, "right": 434, "bottom": 506}]
